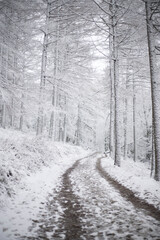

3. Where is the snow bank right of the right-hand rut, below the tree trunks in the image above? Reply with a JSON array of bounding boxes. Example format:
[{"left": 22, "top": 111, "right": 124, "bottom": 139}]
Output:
[{"left": 101, "top": 158, "right": 160, "bottom": 209}]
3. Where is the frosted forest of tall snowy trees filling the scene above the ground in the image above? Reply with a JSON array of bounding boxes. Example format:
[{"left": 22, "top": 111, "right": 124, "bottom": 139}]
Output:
[{"left": 0, "top": 0, "right": 160, "bottom": 180}]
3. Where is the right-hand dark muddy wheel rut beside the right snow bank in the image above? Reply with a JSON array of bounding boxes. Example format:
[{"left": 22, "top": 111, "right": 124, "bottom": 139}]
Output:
[{"left": 96, "top": 158, "right": 160, "bottom": 221}]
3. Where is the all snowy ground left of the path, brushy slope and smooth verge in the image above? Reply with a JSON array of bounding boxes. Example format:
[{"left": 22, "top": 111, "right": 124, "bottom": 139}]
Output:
[{"left": 0, "top": 129, "right": 89, "bottom": 240}]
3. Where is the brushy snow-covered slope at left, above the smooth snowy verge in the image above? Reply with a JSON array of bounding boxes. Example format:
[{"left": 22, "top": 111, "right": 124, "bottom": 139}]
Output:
[{"left": 0, "top": 129, "right": 85, "bottom": 206}]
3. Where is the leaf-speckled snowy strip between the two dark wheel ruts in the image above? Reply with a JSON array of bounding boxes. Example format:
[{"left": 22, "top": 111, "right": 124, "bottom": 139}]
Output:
[{"left": 70, "top": 157, "right": 160, "bottom": 240}]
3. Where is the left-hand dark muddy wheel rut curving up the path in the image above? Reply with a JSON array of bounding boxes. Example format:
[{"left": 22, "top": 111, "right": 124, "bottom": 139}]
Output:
[{"left": 59, "top": 153, "right": 97, "bottom": 240}]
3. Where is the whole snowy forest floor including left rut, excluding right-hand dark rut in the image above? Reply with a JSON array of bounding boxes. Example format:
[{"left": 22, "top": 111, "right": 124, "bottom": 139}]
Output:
[{"left": 0, "top": 129, "right": 160, "bottom": 240}]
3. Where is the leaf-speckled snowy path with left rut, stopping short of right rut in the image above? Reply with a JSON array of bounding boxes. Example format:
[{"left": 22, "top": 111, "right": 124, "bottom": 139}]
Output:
[{"left": 22, "top": 156, "right": 160, "bottom": 240}]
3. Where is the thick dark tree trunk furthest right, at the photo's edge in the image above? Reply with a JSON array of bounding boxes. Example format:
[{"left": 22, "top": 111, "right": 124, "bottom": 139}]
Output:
[{"left": 145, "top": 0, "right": 160, "bottom": 181}]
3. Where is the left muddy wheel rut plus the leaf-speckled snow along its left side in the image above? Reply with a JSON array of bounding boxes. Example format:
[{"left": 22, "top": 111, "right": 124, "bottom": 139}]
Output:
[{"left": 22, "top": 153, "right": 96, "bottom": 240}]
